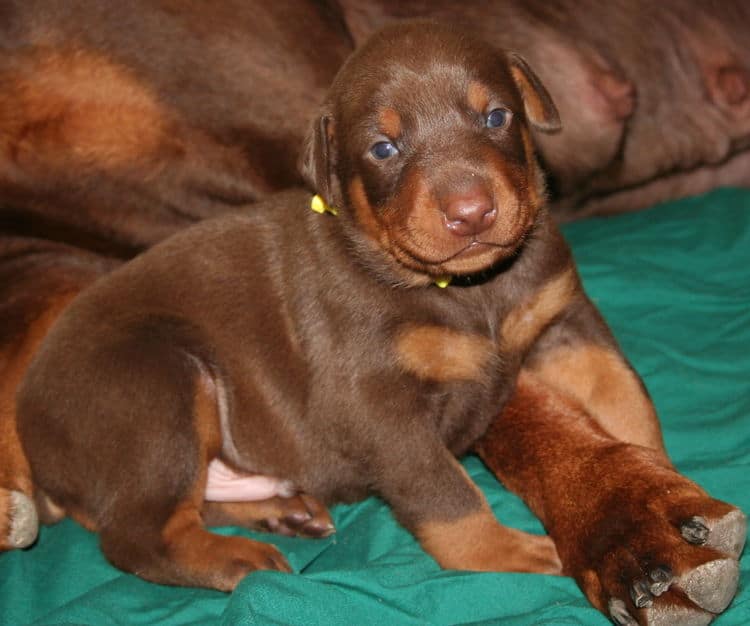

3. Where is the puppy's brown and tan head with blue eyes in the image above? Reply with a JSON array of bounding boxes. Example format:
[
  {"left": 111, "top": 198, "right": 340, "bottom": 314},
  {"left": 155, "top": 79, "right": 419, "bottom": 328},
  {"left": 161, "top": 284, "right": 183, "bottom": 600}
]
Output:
[{"left": 301, "top": 21, "right": 560, "bottom": 283}]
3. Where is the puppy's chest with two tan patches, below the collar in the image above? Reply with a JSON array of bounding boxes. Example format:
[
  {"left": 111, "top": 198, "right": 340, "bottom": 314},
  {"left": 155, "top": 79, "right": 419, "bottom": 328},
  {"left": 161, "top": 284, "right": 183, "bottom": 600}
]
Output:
[{"left": 391, "top": 268, "right": 576, "bottom": 438}]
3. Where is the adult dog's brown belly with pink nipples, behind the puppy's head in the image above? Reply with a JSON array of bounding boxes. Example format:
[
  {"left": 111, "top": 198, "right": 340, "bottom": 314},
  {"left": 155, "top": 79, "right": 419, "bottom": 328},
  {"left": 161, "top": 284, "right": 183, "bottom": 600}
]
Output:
[{"left": 340, "top": 0, "right": 750, "bottom": 219}]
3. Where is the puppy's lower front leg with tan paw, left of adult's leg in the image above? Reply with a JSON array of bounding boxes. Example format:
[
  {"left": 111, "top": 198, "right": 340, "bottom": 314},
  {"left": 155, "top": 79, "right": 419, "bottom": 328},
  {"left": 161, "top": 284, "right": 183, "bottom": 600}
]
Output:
[{"left": 377, "top": 438, "right": 562, "bottom": 574}]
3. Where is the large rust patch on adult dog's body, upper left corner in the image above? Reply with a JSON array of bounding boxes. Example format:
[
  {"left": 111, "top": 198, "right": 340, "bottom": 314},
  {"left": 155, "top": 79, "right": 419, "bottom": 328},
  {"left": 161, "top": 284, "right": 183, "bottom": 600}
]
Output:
[{"left": 0, "top": 48, "right": 170, "bottom": 168}]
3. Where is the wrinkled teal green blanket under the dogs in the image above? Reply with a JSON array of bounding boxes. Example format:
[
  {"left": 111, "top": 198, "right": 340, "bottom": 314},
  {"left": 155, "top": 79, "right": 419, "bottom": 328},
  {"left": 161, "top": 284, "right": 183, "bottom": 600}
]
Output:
[{"left": 0, "top": 190, "right": 750, "bottom": 626}]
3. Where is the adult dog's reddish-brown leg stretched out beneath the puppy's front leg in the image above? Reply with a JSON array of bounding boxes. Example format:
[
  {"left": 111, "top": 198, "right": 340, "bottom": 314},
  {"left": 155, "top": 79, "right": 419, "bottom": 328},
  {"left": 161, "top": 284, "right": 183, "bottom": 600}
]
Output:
[{"left": 477, "top": 370, "right": 744, "bottom": 624}]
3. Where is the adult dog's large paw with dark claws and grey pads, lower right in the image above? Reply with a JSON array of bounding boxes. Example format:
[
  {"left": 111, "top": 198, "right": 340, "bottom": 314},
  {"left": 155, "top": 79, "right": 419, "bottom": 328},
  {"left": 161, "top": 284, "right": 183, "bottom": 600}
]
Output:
[{"left": 558, "top": 446, "right": 747, "bottom": 626}]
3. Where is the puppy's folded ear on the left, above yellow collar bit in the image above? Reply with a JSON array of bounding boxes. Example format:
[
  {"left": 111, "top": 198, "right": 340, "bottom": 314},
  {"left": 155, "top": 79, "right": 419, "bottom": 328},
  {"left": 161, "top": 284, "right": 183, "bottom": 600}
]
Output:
[{"left": 298, "top": 111, "right": 341, "bottom": 207}]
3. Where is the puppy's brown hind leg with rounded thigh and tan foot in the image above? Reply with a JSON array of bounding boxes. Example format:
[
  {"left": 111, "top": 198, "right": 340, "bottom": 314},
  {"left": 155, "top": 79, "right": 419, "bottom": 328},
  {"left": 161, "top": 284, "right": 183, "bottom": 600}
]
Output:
[{"left": 19, "top": 318, "right": 289, "bottom": 591}]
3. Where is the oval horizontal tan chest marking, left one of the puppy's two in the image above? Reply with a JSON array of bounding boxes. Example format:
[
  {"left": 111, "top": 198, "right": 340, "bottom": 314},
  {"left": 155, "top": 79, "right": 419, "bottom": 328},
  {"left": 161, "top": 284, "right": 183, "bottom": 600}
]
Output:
[{"left": 396, "top": 324, "right": 497, "bottom": 382}]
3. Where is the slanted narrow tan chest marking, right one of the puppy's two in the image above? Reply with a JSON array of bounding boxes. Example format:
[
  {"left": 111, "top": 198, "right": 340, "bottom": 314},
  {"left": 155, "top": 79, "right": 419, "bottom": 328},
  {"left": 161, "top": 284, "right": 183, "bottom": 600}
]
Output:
[{"left": 500, "top": 266, "right": 580, "bottom": 351}]
